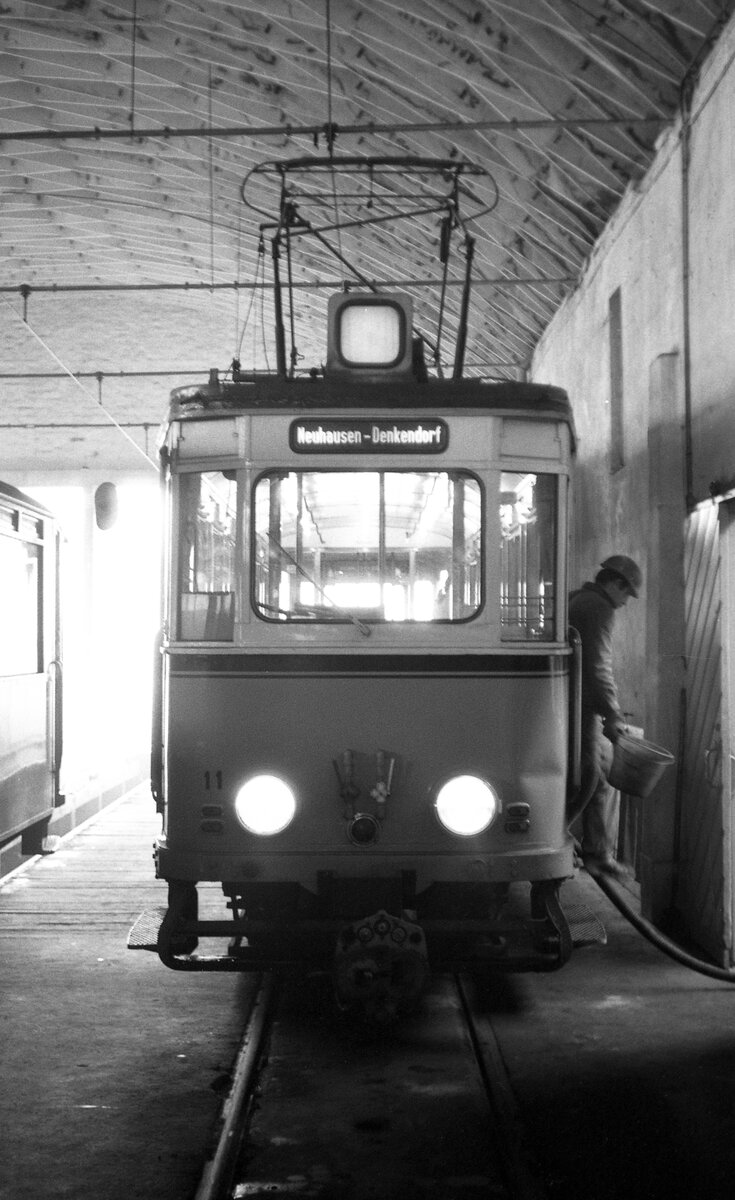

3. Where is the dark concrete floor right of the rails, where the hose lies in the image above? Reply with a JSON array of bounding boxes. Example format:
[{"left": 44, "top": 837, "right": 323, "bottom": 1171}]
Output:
[{"left": 482, "top": 872, "right": 735, "bottom": 1200}]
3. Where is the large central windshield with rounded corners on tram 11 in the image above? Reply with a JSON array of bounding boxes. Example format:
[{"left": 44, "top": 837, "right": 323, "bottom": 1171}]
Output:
[{"left": 252, "top": 470, "right": 483, "bottom": 622}]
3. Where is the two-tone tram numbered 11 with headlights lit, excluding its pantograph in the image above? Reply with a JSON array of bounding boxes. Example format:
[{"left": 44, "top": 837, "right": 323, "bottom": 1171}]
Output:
[{"left": 143, "top": 296, "right": 575, "bottom": 1002}]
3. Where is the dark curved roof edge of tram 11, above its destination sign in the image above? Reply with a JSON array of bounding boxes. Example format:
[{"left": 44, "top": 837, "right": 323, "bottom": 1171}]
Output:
[{"left": 168, "top": 376, "right": 572, "bottom": 424}]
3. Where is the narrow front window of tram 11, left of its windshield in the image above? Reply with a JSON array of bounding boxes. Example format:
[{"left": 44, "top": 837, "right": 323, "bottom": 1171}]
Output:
[{"left": 179, "top": 470, "right": 238, "bottom": 642}]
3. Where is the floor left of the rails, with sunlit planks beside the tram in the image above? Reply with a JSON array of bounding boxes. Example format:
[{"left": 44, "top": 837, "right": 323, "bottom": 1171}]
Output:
[{"left": 0, "top": 787, "right": 255, "bottom": 1200}]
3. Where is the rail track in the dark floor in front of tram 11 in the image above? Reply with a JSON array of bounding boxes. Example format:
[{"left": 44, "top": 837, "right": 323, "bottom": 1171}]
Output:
[{"left": 196, "top": 976, "right": 545, "bottom": 1200}]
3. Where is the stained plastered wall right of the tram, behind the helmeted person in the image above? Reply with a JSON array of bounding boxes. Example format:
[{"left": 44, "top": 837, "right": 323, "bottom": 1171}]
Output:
[{"left": 532, "top": 11, "right": 735, "bottom": 936}]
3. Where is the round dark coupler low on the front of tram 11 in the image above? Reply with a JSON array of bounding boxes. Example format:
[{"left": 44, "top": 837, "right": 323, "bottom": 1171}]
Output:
[{"left": 334, "top": 908, "right": 429, "bottom": 1020}]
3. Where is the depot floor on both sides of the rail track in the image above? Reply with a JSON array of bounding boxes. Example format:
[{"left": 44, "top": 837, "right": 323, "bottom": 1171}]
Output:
[{"left": 0, "top": 788, "right": 735, "bottom": 1200}]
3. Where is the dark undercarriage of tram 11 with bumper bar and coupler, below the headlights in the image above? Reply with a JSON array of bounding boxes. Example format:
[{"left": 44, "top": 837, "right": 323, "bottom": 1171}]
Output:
[{"left": 131, "top": 871, "right": 572, "bottom": 1008}]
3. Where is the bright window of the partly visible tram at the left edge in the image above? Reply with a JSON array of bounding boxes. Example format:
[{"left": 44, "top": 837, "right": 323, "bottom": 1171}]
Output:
[{"left": 0, "top": 534, "right": 43, "bottom": 674}]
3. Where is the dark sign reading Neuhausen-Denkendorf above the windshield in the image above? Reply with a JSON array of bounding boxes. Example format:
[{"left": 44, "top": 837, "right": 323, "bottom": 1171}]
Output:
[{"left": 288, "top": 418, "right": 449, "bottom": 454}]
